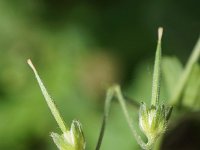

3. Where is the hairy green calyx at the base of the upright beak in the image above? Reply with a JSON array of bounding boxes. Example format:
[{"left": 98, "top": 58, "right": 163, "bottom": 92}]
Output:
[{"left": 139, "top": 103, "right": 172, "bottom": 141}]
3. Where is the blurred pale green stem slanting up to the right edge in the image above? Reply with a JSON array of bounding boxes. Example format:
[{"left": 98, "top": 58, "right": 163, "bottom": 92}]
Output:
[{"left": 170, "top": 38, "right": 200, "bottom": 105}]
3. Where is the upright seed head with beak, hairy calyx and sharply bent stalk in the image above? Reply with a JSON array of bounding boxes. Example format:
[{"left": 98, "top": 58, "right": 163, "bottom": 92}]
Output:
[{"left": 96, "top": 28, "right": 172, "bottom": 150}]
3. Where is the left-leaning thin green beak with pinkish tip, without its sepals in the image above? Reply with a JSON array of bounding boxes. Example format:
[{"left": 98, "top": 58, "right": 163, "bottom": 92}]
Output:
[{"left": 27, "top": 59, "right": 67, "bottom": 133}]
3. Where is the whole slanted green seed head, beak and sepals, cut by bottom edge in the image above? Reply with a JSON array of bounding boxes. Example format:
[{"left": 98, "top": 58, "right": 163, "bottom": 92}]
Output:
[{"left": 27, "top": 59, "right": 86, "bottom": 150}]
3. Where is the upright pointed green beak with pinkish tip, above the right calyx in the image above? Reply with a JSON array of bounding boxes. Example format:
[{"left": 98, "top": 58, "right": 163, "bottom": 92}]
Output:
[{"left": 151, "top": 27, "right": 163, "bottom": 106}]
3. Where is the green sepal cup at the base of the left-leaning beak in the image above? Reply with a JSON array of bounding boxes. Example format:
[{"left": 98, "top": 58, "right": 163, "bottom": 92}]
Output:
[{"left": 51, "top": 120, "right": 85, "bottom": 150}]
